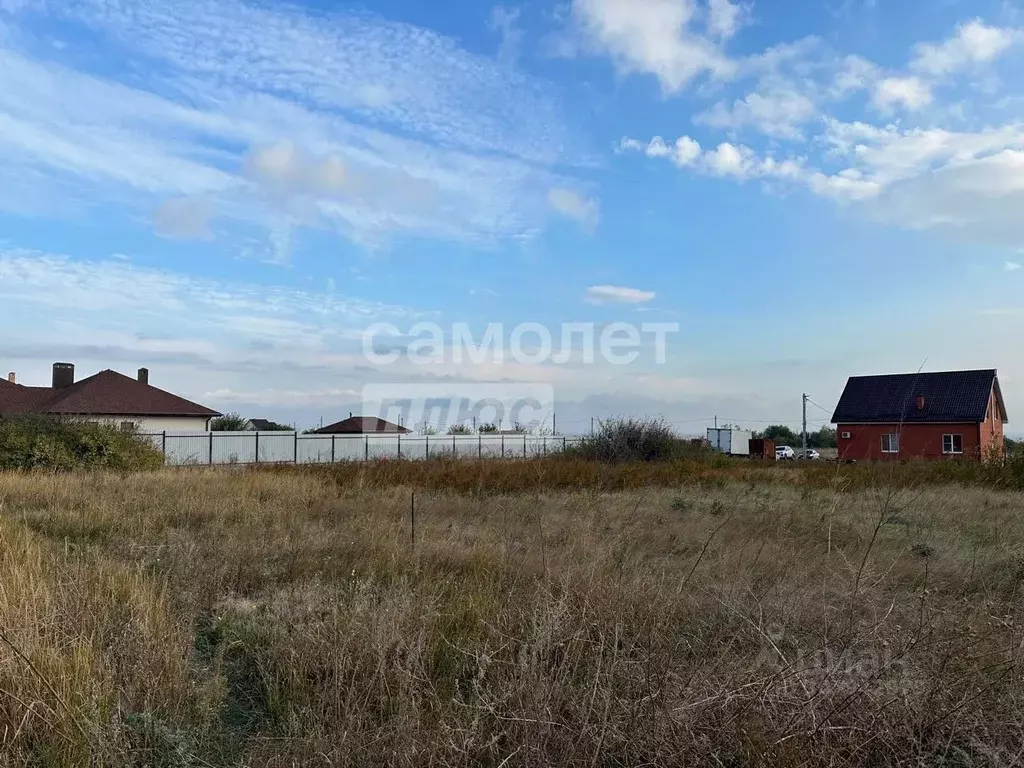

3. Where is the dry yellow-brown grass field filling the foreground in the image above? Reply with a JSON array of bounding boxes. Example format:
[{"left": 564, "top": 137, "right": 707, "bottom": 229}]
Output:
[{"left": 0, "top": 466, "right": 1024, "bottom": 768}]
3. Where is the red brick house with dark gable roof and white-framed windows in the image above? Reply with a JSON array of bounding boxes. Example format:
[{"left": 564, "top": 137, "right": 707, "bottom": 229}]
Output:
[{"left": 831, "top": 370, "right": 1008, "bottom": 461}]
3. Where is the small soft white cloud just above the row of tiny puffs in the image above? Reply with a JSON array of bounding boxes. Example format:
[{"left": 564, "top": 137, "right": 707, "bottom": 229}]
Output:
[{"left": 694, "top": 84, "right": 818, "bottom": 139}]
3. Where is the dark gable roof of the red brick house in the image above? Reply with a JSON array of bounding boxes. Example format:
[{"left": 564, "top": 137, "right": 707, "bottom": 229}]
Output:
[{"left": 833, "top": 370, "right": 1006, "bottom": 424}]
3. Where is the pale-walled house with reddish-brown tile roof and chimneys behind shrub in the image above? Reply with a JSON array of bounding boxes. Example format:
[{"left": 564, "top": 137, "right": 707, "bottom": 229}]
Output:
[{"left": 0, "top": 362, "right": 220, "bottom": 432}]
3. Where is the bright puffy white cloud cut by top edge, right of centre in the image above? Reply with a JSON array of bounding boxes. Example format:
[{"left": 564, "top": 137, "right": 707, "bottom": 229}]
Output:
[{"left": 572, "top": 0, "right": 736, "bottom": 92}]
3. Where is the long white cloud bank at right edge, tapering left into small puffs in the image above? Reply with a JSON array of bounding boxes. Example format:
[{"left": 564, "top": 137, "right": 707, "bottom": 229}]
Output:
[{"left": 623, "top": 120, "right": 1024, "bottom": 236}]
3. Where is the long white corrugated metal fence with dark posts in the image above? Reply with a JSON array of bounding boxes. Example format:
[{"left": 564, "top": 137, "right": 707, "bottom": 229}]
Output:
[{"left": 143, "top": 432, "right": 574, "bottom": 466}]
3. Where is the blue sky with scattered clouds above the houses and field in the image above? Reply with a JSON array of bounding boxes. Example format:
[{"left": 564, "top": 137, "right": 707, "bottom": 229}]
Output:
[{"left": 0, "top": 0, "right": 1024, "bottom": 431}]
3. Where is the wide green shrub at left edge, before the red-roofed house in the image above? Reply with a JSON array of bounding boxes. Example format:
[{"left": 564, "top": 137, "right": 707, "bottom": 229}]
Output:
[{"left": 0, "top": 416, "right": 163, "bottom": 471}]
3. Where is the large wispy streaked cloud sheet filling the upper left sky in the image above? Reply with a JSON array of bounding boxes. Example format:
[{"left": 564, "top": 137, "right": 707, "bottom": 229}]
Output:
[{"left": 0, "top": 0, "right": 579, "bottom": 242}]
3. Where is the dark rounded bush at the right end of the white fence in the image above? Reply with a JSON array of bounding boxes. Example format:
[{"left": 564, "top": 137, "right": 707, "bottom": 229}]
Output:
[{"left": 566, "top": 419, "right": 717, "bottom": 462}]
